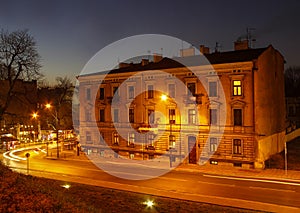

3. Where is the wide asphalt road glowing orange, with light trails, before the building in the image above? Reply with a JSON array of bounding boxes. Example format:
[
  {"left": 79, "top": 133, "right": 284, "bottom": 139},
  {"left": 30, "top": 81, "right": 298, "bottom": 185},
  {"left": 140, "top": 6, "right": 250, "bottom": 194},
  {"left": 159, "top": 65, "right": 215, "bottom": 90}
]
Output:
[{"left": 3, "top": 146, "right": 300, "bottom": 212}]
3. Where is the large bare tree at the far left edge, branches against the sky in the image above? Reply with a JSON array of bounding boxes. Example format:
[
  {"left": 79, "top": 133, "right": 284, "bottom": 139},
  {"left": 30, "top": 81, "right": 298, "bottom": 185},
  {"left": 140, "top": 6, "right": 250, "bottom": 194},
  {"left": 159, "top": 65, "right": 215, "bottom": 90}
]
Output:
[{"left": 0, "top": 30, "right": 42, "bottom": 120}]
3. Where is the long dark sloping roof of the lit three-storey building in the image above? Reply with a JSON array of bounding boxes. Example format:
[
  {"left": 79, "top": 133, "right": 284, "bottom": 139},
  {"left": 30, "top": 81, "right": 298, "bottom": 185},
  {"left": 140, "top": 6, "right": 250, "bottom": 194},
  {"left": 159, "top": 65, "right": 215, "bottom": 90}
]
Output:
[{"left": 82, "top": 47, "right": 268, "bottom": 76}]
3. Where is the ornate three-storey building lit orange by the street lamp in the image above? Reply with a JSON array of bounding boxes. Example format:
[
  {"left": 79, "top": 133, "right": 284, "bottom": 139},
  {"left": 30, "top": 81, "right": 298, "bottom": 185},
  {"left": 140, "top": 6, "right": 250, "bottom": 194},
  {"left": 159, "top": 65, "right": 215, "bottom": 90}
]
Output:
[{"left": 78, "top": 40, "right": 285, "bottom": 168}]
